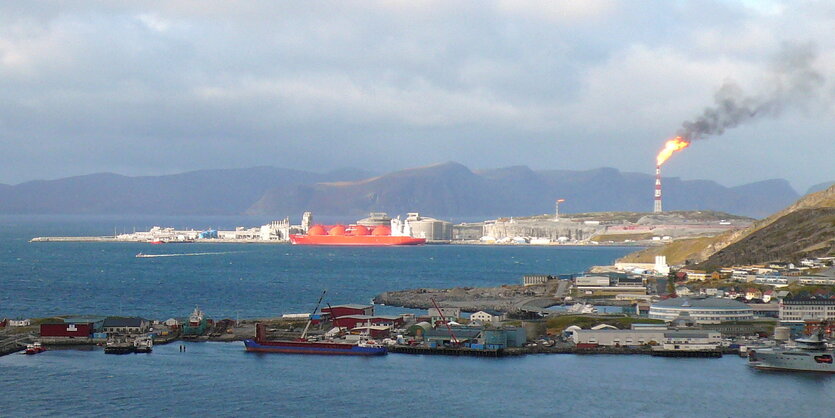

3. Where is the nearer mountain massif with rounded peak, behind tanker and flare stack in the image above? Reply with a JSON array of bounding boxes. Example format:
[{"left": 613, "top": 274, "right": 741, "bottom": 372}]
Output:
[{"left": 247, "top": 162, "right": 799, "bottom": 218}]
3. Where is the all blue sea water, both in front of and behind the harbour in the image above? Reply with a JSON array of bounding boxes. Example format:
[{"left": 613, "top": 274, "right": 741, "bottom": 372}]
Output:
[{"left": 0, "top": 217, "right": 835, "bottom": 417}]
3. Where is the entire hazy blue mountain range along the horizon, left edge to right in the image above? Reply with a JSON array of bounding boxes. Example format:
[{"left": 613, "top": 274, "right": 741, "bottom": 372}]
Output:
[{"left": 0, "top": 162, "right": 799, "bottom": 219}]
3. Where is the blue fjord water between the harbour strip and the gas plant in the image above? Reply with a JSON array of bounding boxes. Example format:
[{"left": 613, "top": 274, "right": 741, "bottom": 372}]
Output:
[{"left": 0, "top": 220, "right": 633, "bottom": 320}]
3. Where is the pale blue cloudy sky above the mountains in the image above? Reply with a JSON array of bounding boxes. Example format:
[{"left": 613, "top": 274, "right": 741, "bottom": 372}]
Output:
[{"left": 0, "top": 0, "right": 835, "bottom": 192}]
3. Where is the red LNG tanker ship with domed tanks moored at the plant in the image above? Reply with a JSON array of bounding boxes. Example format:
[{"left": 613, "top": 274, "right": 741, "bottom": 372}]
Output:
[{"left": 290, "top": 225, "right": 426, "bottom": 246}]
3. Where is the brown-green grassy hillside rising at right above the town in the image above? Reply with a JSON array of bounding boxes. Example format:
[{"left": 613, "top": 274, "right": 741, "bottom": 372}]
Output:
[{"left": 621, "top": 186, "right": 835, "bottom": 269}]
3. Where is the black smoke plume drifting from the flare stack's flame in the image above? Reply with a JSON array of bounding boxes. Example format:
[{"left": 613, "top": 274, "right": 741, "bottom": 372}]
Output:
[{"left": 678, "top": 43, "right": 825, "bottom": 141}]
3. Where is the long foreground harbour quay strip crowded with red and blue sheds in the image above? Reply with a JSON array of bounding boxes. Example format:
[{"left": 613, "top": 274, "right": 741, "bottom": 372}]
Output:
[{"left": 0, "top": 304, "right": 739, "bottom": 358}]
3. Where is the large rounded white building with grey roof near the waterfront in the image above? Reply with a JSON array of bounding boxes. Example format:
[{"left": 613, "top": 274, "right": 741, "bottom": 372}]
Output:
[{"left": 649, "top": 297, "right": 754, "bottom": 324}]
